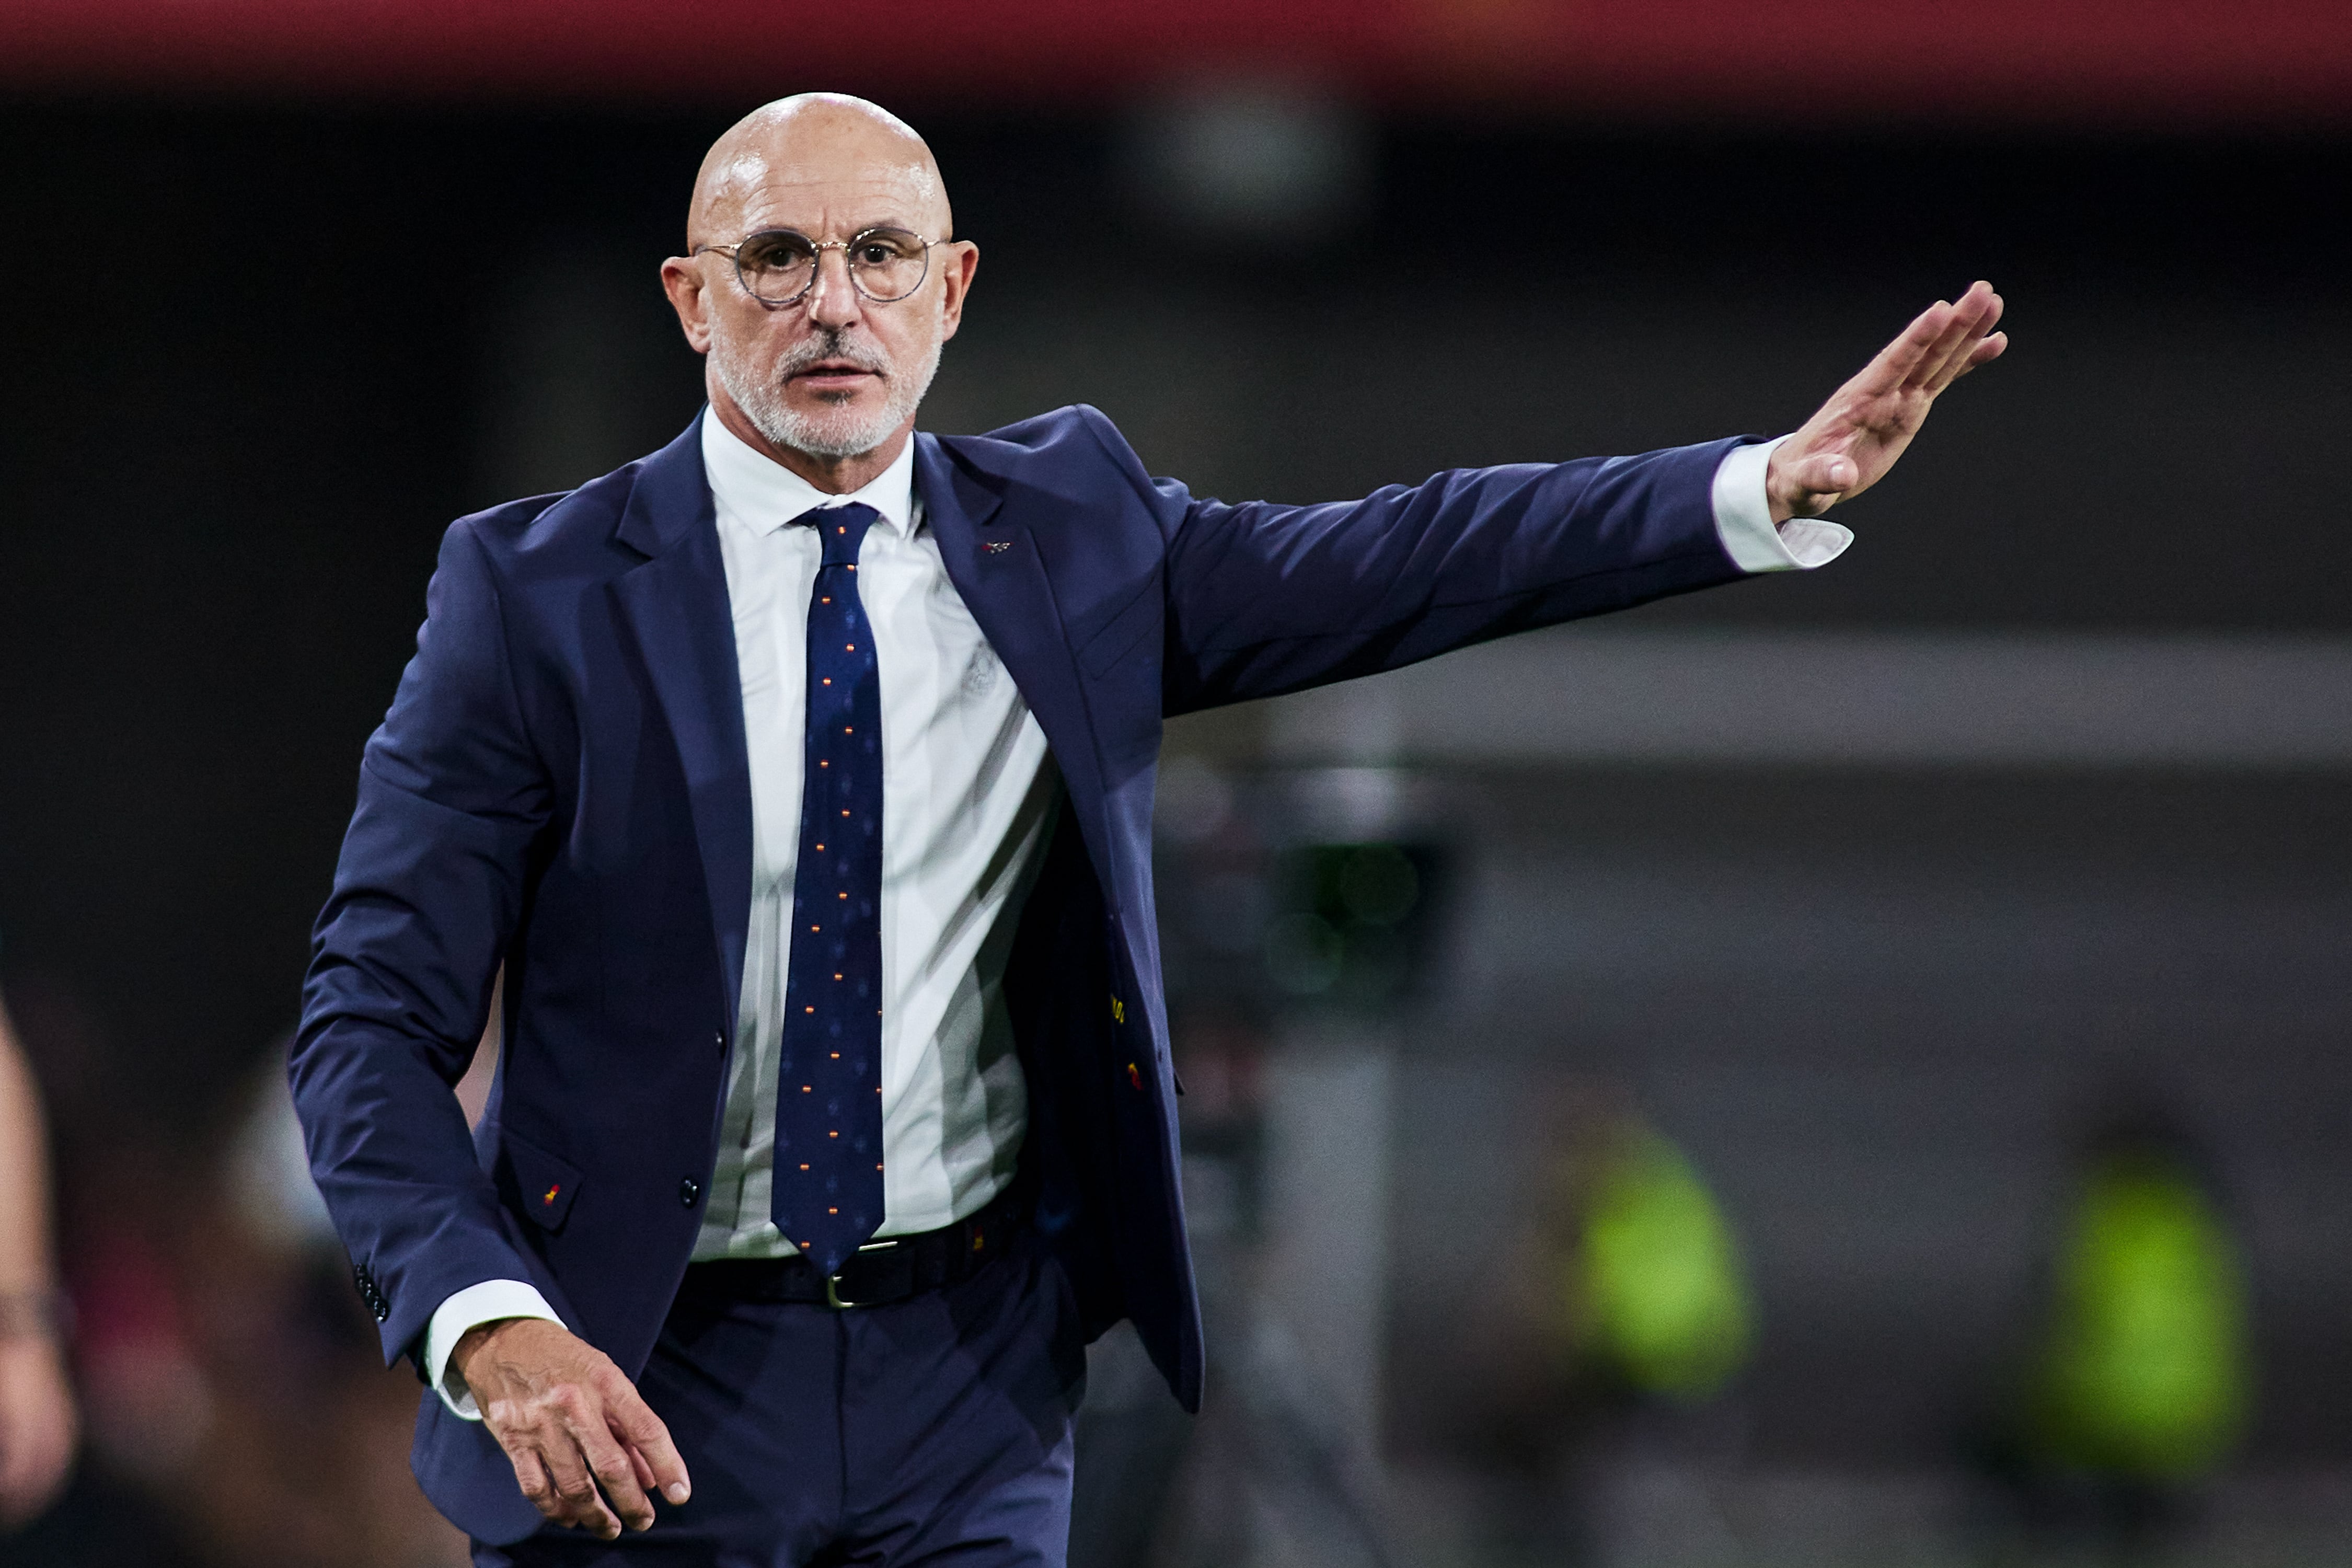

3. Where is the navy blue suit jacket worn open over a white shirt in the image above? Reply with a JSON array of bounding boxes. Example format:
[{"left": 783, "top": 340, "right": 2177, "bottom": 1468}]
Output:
[{"left": 292, "top": 407, "right": 1740, "bottom": 1542}]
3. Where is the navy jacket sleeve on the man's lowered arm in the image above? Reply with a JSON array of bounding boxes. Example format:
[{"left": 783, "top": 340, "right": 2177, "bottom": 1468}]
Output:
[{"left": 290, "top": 520, "right": 550, "bottom": 1361}]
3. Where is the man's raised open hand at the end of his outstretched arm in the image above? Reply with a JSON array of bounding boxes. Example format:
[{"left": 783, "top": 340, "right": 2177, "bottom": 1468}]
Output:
[{"left": 1764, "top": 282, "right": 2009, "bottom": 522}]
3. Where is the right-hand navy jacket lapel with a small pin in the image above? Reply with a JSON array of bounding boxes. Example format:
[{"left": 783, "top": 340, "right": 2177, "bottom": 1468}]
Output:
[{"left": 915, "top": 435, "right": 1110, "bottom": 872}]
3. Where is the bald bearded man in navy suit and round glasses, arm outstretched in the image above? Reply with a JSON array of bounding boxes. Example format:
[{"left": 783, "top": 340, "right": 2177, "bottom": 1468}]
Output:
[{"left": 292, "top": 94, "right": 2004, "bottom": 1563}]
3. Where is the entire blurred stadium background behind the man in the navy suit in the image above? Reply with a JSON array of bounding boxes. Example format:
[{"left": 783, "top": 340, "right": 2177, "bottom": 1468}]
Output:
[{"left": 0, "top": 0, "right": 2352, "bottom": 1568}]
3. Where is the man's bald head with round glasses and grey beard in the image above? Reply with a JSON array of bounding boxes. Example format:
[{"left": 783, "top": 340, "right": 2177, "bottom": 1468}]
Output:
[{"left": 661, "top": 91, "right": 978, "bottom": 489}]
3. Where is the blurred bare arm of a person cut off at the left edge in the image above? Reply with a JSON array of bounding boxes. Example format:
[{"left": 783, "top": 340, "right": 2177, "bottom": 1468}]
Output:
[{"left": 0, "top": 1004, "right": 78, "bottom": 1530}]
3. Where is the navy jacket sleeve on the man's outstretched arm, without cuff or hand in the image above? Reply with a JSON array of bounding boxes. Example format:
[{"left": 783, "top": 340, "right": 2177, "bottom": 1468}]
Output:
[{"left": 1124, "top": 421, "right": 1745, "bottom": 714}]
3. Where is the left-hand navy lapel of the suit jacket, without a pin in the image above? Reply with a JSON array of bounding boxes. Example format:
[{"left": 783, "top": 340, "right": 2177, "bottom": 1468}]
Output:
[{"left": 612, "top": 419, "right": 751, "bottom": 1034}]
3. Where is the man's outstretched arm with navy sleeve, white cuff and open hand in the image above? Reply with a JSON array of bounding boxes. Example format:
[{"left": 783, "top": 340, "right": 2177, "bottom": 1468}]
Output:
[{"left": 1155, "top": 282, "right": 2009, "bottom": 712}]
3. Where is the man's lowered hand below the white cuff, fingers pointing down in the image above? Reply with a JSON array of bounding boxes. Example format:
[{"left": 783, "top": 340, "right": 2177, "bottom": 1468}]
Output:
[{"left": 449, "top": 1317, "right": 689, "bottom": 1540}]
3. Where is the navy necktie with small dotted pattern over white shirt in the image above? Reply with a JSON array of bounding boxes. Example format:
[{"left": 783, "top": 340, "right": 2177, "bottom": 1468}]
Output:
[{"left": 769, "top": 503, "right": 882, "bottom": 1274}]
